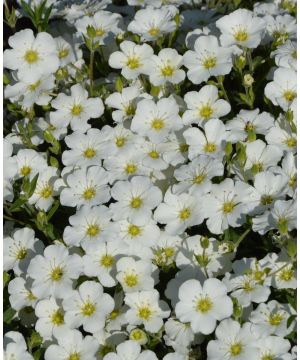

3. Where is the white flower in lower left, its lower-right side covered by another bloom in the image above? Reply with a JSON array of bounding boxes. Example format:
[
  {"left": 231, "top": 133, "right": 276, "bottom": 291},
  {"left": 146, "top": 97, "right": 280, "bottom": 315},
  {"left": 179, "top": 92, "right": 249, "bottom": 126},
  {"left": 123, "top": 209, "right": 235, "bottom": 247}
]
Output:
[{"left": 83, "top": 239, "right": 127, "bottom": 287}]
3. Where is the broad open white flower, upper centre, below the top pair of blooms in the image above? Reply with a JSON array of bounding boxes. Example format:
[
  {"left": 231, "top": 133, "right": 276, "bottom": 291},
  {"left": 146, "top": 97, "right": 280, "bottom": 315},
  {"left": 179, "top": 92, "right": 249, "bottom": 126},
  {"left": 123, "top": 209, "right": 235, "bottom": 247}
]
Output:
[{"left": 131, "top": 97, "right": 182, "bottom": 143}]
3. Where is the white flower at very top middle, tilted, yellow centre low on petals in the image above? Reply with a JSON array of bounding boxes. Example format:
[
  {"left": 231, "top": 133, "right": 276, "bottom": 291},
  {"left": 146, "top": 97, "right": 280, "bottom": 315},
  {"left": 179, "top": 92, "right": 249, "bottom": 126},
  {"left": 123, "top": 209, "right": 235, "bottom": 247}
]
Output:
[{"left": 127, "top": 6, "right": 177, "bottom": 41}]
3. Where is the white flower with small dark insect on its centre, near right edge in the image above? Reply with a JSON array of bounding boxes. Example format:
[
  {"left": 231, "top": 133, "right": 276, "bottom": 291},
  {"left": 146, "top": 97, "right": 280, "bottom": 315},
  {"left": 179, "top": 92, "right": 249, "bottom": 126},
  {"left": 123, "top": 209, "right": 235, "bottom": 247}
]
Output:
[{"left": 226, "top": 109, "right": 274, "bottom": 143}]
